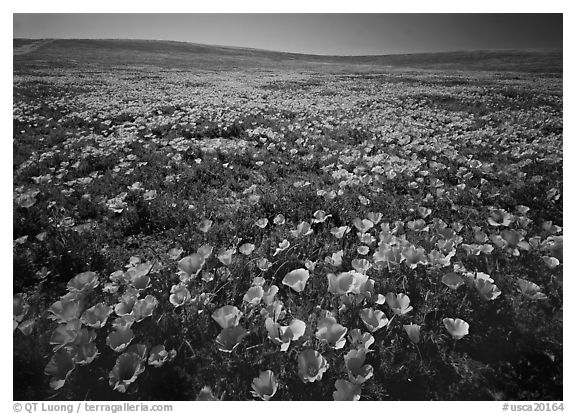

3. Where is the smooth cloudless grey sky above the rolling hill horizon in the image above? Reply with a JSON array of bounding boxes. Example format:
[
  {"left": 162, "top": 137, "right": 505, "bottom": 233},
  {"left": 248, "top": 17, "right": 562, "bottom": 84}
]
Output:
[{"left": 14, "top": 13, "right": 563, "bottom": 55}]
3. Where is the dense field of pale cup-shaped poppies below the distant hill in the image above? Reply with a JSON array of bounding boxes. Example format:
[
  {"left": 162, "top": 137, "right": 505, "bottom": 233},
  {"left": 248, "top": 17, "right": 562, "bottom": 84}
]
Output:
[{"left": 13, "top": 41, "right": 563, "bottom": 400}]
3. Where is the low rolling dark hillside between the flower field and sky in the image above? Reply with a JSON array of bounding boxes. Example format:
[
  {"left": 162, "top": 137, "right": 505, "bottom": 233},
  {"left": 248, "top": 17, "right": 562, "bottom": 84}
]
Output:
[{"left": 14, "top": 39, "right": 562, "bottom": 73}]
